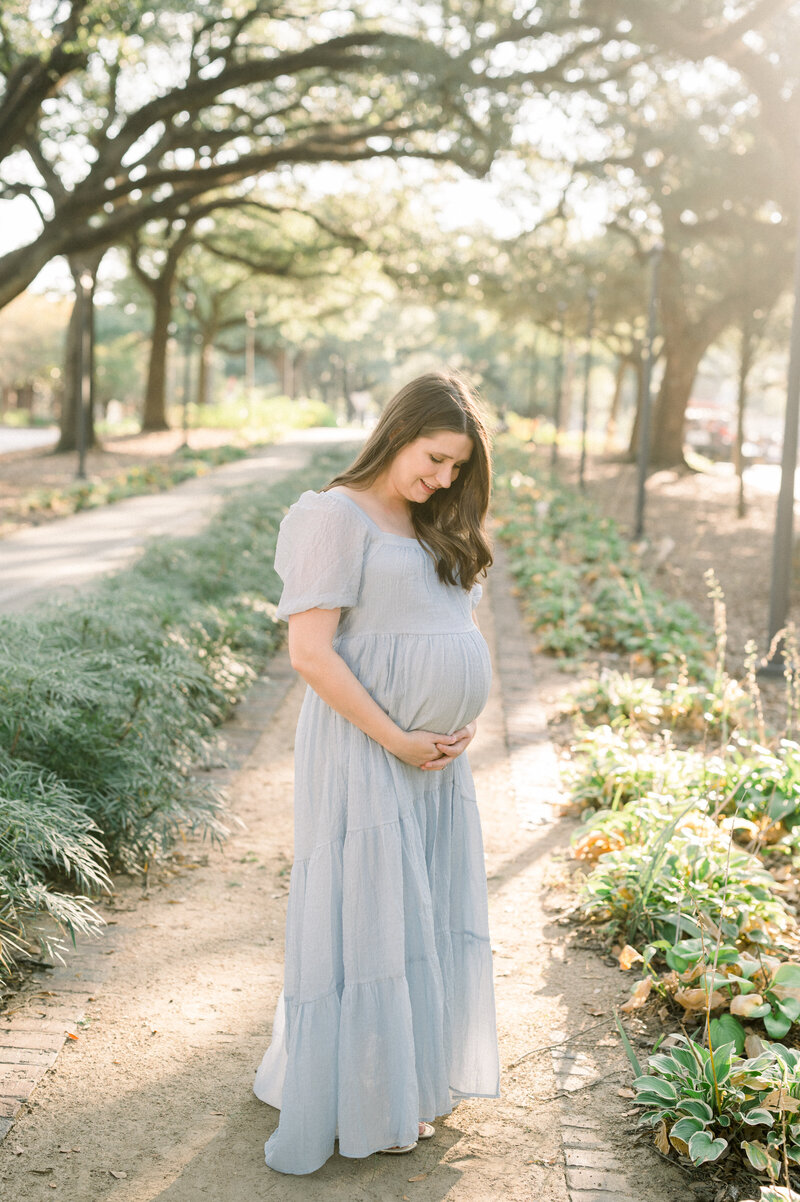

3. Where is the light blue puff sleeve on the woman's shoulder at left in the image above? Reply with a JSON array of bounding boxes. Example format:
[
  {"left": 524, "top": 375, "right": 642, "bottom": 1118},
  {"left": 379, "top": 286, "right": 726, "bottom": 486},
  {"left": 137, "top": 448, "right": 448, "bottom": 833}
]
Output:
[{"left": 275, "top": 492, "right": 368, "bottom": 620}]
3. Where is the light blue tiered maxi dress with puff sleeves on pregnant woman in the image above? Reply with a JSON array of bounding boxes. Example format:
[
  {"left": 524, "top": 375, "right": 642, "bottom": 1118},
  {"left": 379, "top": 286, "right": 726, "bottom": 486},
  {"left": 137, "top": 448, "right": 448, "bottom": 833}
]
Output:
[{"left": 253, "top": 492, "right": 500, "bottom": 1173}]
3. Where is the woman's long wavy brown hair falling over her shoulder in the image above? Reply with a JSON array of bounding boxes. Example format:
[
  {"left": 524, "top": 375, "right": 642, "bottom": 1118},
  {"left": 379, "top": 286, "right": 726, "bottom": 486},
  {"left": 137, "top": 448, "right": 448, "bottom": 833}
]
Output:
[{"left": 323, "top": 371, "right": 492, "bottom": 589}]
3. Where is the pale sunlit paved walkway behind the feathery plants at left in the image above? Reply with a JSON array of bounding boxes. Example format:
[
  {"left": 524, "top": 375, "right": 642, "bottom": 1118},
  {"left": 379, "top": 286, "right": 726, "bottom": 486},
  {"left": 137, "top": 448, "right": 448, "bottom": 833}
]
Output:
[{"left": 0, "top": 428, "right": 362, "bottom": 613}]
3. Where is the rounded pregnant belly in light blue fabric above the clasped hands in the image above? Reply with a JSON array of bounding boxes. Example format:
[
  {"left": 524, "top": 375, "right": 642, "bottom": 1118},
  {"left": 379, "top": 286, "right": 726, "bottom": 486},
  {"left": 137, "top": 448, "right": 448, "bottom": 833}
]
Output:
[{"left": 339, "top": 626, "right": 491, "bottom": 734}]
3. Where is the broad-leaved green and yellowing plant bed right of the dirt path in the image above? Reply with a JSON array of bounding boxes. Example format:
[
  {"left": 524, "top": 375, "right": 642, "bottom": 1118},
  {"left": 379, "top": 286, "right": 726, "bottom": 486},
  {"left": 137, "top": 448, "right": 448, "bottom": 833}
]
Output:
[{"left": 497, "top": 439, "right": 800, "bottom": 1182}]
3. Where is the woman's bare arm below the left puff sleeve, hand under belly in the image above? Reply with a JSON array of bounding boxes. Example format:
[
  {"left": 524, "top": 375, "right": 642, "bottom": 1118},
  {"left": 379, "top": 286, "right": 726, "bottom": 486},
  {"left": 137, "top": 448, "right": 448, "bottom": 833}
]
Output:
[{"left": 288, "top": 609, "right": 456, "bottom": 770}]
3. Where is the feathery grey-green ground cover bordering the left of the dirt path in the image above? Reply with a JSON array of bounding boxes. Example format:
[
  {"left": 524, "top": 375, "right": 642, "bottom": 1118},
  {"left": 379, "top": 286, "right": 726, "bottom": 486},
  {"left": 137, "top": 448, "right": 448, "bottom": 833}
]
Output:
[{"left": 0, "top": 450, "right": 347, "bottom": 978}]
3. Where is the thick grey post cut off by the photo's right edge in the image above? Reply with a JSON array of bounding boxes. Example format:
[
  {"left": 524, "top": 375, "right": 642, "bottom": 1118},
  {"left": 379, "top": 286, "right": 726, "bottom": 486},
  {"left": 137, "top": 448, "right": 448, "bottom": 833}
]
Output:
[{"left": 758, "top": 204, "right": 800, "bottom": 676}]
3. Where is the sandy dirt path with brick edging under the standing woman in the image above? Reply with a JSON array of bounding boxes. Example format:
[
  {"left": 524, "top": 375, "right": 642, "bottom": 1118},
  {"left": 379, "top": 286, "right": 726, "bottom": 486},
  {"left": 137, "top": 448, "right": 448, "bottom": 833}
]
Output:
[{"left": 0, "top": 550, "right": 685, "bottom": 1202}]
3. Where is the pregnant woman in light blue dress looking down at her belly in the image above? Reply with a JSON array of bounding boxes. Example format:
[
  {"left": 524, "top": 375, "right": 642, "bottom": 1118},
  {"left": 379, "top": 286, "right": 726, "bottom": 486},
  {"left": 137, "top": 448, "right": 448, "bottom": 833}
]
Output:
[{"left": 255, "top": 373, "right": 498, "bottom": 1173}]
